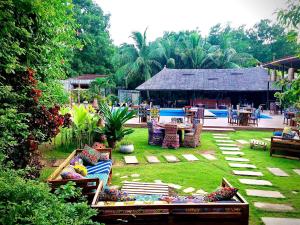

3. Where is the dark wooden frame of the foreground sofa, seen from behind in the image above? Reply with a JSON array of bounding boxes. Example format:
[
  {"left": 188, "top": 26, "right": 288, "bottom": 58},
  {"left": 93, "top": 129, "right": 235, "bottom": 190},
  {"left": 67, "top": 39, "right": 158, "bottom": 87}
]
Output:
[{"left": 92, "top": 178, "right": 249, "bottom": 225}]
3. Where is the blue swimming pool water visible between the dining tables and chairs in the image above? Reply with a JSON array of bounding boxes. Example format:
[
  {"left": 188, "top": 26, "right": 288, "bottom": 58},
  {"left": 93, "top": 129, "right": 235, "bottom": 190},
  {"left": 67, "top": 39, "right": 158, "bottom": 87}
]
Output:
[{"left": 160, "top": 109, "right": 272, "bottom": 119}]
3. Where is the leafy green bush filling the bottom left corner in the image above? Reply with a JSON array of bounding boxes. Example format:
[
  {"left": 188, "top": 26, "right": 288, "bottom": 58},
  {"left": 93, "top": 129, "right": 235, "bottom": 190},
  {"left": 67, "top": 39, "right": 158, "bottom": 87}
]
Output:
[{"left": 0, "top": 156, "right": 99, "bottom": 225}]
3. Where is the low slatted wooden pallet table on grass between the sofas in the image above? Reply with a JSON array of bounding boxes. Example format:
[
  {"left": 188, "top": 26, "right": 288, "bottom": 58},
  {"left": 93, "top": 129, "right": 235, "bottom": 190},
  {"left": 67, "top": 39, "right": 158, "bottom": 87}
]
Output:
[{"left": 121, "top": 181, "right": 169, "bottom": 195}]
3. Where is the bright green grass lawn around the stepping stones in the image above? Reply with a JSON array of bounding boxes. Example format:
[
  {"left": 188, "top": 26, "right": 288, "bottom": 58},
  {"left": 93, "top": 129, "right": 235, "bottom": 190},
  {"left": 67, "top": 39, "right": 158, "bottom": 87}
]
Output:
[{"left": 41, "top": 129, "right": 300, "bottom": 224}]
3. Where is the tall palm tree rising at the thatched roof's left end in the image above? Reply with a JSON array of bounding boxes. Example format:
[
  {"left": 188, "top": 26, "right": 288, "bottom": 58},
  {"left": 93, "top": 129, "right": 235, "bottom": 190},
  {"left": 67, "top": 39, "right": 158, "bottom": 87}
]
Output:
[{"left": 120, "top": 29, "right": 163, "bottom": 99}]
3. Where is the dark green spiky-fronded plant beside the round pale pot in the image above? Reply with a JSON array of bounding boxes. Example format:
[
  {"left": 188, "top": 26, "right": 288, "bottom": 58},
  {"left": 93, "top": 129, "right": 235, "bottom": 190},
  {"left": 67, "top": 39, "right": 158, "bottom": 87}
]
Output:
[{"left": 95, "top": 103, "right": 136, "bottom": 148}]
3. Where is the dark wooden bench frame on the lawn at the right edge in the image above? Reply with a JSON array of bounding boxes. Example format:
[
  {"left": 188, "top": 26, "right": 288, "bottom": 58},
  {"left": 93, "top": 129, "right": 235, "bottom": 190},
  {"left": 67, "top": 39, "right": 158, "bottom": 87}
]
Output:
[{"left": 270, "top": 136, "right": 300, "bottom": 157}]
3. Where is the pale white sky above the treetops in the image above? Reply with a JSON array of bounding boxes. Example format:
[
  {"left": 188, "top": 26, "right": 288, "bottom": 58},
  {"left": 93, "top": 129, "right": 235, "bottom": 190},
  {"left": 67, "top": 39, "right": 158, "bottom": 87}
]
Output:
[{"left": 94, "top": 0, "right": 286, "bottom": 45}]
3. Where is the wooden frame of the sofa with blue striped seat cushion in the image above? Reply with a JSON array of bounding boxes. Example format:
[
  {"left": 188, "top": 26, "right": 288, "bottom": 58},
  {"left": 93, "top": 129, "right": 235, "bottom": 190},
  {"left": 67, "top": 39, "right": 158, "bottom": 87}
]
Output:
[{"left": 47, "top": 148, "right": 112, "bottom": 202}]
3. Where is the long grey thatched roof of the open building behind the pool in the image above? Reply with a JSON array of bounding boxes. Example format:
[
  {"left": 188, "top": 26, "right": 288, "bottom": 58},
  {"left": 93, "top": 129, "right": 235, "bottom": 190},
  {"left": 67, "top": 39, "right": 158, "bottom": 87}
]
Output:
[{"left": 136, "top": 67, "right": 276, "bottom": 91}]
